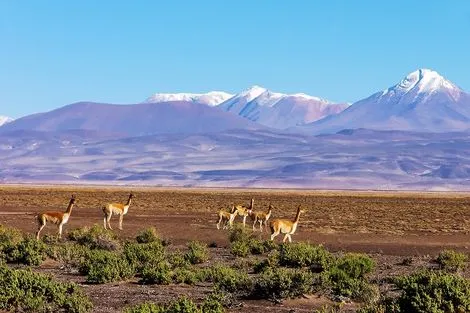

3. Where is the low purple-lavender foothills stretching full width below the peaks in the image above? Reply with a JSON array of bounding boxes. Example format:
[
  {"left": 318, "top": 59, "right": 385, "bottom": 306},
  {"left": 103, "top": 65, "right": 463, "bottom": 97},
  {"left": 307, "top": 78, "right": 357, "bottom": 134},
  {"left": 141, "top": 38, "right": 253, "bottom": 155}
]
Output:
[{"left": 0, "top": 129, "right": 470, "bottom": 191}]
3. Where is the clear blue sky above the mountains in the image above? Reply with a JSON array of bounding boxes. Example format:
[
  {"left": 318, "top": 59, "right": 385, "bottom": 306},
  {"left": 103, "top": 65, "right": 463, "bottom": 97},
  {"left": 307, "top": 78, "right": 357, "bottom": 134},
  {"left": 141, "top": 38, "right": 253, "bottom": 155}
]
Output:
[{"left": 0, "top": 0, "right": 470, "bottom": 118}]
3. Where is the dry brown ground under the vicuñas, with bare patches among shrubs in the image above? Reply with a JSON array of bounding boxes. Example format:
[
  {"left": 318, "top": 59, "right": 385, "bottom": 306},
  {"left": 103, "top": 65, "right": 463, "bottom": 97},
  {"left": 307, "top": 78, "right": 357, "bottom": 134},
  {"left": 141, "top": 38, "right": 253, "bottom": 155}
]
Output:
[{"left": 0, "top": 185, "right": 470, "bottom": 312}]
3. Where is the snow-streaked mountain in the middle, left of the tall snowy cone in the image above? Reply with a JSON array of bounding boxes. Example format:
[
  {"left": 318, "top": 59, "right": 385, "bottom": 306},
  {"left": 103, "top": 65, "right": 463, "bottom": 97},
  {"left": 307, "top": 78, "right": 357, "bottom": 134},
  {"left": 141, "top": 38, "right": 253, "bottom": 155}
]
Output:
[{"left": 217, "top": 86, "right": 348, "bottom": 129}]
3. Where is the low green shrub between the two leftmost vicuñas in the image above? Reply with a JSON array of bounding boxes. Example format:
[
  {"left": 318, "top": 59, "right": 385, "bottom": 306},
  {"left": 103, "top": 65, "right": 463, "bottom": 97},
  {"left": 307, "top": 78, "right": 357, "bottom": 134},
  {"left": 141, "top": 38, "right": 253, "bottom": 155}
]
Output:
[{"left": 68, "top": 224, "right": 121, "bottom": 251}]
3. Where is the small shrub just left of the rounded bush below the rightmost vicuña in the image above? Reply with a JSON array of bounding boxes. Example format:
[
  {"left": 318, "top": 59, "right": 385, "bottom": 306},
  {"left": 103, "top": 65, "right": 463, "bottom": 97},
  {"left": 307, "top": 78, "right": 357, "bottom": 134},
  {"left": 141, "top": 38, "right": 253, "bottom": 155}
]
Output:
[{"left": 206, "top": 264, "right": 251, "bottom": 294}]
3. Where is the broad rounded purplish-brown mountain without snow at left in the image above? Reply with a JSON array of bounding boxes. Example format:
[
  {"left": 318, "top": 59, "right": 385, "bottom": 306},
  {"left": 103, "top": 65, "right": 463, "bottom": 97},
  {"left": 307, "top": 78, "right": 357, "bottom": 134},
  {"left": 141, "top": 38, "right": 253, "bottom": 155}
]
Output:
[{"left": 0, "top": 101, "right": 263, "bottom": 136}]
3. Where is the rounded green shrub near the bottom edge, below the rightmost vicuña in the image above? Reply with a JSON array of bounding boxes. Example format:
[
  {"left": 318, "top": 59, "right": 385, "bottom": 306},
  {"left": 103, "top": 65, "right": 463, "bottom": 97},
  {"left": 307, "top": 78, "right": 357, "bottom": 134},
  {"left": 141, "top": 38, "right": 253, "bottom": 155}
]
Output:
[{"left": 251, "top": 267, "right": 318, "bottom": 300}]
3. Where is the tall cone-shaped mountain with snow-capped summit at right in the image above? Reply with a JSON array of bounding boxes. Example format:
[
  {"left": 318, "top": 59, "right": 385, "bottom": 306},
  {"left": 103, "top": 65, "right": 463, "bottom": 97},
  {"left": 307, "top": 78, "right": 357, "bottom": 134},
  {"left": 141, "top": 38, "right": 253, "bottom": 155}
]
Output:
[{"left": 297, "top": 69, "right": 470, "bottom": 134}]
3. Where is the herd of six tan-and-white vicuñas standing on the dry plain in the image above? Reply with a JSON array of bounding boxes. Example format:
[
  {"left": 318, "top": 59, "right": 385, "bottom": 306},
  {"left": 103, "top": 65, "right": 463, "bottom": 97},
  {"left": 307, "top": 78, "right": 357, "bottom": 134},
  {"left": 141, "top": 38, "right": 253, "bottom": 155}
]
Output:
[{"left": 36, "top": 192, "right": 305, "bottom": 242}]
